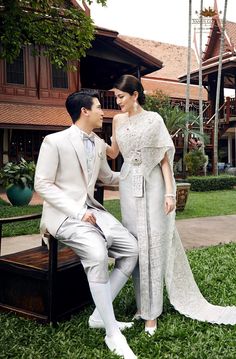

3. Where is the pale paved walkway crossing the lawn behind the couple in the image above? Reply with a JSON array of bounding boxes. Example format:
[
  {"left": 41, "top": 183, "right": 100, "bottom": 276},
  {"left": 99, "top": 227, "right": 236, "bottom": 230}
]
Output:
[{"left": 0, "top": 191, "right": 236, "bottom": 254}]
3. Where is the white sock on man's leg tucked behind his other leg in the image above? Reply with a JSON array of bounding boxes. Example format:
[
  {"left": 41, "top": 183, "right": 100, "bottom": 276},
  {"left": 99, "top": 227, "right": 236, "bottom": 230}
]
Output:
[{"left": 91, "top": 268, "right": 128, "bottom": 320}]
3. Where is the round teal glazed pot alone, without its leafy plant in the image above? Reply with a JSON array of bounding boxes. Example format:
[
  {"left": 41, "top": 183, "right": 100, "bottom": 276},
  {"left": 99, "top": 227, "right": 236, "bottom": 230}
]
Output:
[{"left": 6, "top": 185, "right": 33, "bottom": 206}]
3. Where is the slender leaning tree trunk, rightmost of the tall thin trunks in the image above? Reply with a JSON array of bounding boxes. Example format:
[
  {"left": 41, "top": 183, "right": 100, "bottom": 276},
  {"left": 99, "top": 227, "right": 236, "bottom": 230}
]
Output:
[{"left": 213, "top": 0, "right": 228, "bottom": 176}]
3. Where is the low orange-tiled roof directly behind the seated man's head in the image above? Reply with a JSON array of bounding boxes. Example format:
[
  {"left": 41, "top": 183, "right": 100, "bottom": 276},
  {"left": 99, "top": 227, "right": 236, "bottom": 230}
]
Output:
[{"left": 0, "top": 102, "right": 117, "bottom": 130}]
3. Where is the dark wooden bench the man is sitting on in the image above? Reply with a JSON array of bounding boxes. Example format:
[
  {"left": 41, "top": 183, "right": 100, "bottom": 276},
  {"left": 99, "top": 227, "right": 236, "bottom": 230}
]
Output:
[{"left": 0, "top": 188, "right": 103, "bottom": 324}]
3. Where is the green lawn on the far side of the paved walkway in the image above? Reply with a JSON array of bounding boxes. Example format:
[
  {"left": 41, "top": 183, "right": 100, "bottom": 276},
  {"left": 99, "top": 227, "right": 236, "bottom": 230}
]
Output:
[{"left": 0, "top": 190, "right": 236, "bottom": 237}]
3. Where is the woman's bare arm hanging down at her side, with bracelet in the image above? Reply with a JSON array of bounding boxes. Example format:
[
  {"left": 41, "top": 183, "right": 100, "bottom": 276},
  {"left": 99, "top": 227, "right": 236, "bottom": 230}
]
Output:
[{"left": 161, "top": 153, "right": 176, "bottom": 214}]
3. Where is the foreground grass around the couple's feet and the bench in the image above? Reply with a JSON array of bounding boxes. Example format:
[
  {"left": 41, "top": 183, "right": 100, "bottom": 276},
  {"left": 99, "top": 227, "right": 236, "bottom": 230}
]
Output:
[{"left": 0, "top": 244, "right": 236, "bottom": 359}]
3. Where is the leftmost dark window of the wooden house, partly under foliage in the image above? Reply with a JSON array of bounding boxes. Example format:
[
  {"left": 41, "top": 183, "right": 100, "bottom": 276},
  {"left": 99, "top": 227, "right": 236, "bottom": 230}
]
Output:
[{"left": 6, "top": 49, "right": 25, "bottom": 85}]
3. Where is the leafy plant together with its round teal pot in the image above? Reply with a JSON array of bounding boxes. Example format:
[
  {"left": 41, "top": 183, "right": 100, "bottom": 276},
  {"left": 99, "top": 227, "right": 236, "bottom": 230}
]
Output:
[{"left": 0, "top": 158, "right": 35, "bottom": 206}]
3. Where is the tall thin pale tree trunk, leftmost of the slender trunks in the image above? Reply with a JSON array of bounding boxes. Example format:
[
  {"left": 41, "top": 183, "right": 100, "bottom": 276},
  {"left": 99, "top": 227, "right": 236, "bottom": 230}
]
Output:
[{"left": 183, "top": 0, "right": 192, "bottom": 175}]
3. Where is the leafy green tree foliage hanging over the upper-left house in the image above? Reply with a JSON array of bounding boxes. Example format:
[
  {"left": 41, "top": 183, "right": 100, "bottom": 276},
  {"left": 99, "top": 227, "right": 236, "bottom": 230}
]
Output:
[{"left": 0, "top": 0, "right": 106, "bottom": 67}]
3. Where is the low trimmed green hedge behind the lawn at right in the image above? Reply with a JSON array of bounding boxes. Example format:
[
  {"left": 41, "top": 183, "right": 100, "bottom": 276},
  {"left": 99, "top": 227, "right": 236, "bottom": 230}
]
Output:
[{"left": 187, "top": 175, "right": 236, "bottom": 192}]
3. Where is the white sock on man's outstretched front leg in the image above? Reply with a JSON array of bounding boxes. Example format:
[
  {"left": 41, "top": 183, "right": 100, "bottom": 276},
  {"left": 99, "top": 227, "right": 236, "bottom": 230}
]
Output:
[{"left": 89, "top": 281, "right": 120, "bottom": 336}]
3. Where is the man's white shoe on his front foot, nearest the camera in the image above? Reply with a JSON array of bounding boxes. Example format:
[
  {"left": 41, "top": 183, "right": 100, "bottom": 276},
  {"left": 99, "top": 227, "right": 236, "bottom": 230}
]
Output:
[{"left": 105, "top": 334, "right": 137, "bottom": 359}]
